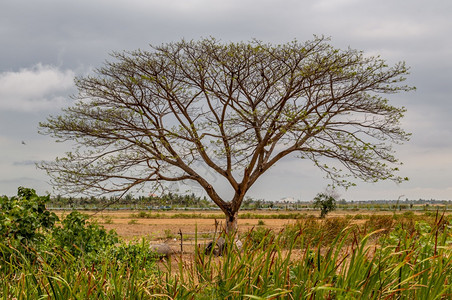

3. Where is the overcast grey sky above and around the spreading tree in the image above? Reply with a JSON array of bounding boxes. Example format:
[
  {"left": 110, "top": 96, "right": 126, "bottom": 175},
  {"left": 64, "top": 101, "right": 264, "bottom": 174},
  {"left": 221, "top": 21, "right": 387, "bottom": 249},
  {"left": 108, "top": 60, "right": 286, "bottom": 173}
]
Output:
[{"left": 0, "top": 0, "right": 452, "bottom": 200}]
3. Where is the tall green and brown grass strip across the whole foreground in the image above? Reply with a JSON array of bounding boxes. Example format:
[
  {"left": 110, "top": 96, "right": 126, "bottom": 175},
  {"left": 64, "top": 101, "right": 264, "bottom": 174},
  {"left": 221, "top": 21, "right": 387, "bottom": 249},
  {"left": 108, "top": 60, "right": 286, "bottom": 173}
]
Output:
[{"left": 0, "top": 215, "right": 452, "bottom": 299}]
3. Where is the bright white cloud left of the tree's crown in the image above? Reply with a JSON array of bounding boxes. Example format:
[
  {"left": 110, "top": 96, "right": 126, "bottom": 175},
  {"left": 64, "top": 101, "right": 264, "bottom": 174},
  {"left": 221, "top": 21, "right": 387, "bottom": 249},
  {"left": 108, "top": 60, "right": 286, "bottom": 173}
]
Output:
[{"left": 0, "top": 64, "right": 75, "bottom": 112}]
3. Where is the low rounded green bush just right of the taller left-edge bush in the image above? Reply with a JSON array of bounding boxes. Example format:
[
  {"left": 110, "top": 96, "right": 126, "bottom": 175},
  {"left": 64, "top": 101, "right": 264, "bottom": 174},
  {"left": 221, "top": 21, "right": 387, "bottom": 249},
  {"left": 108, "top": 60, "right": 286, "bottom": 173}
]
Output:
[{"left": 52, "top": 211, "right": 119, "bottom": 256}]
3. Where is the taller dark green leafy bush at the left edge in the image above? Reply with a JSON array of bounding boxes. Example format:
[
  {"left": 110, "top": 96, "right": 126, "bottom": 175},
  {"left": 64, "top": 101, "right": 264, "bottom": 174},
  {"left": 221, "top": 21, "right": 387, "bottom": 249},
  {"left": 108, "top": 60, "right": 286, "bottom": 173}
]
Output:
[{"left": 0, "top": 187, "right": 58, "bottom": 246}]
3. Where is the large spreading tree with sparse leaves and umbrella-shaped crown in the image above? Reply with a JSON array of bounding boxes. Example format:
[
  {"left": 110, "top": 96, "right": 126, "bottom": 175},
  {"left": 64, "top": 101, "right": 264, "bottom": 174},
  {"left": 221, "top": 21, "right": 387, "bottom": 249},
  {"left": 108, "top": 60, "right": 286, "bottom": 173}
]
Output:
[{"left": 40, "top": 37, "right": 411, "bottom": 230}]
